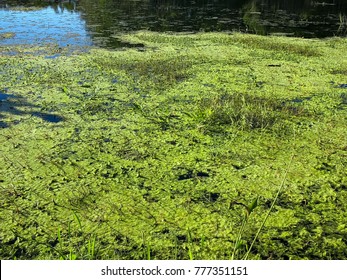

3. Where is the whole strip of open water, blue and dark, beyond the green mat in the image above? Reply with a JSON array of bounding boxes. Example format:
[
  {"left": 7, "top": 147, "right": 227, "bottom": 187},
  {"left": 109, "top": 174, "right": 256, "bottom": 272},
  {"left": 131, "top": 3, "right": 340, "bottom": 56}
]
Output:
[{"left": 0, "top": 0, "right": 347, "bottom": 48}]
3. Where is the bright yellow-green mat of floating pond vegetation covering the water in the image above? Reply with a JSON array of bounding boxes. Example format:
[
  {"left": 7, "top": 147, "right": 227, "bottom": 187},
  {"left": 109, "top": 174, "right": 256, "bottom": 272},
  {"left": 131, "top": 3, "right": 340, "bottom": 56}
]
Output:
[{"left": 0, "top": 32, "right": 347, "bottom": 260}]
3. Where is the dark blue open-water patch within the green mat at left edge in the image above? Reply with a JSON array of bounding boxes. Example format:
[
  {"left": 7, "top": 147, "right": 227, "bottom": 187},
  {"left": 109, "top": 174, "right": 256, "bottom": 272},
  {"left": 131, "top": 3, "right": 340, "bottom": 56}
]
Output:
[{"left": 0, "top": 91, "right": 64, "bottom": 128}]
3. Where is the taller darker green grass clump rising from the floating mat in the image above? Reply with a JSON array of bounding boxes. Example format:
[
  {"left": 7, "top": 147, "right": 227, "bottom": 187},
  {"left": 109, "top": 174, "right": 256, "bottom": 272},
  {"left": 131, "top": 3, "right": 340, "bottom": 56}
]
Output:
[{"left": 195, "top": 93, "right": 304, "bottom": 130}]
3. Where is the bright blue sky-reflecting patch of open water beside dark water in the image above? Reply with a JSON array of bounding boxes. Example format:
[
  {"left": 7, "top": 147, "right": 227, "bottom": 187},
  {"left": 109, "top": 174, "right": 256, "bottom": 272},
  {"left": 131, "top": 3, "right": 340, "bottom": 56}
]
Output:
[{"left": 0, "top": 2, "right": 93, "bottom": 46}]
